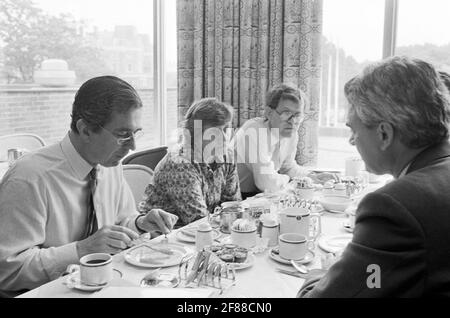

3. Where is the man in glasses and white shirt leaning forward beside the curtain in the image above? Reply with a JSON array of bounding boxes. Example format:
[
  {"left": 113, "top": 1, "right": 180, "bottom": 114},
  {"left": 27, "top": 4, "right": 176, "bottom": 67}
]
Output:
[{"left": 235, "top": 84, "right": 328, "bottom": 198}]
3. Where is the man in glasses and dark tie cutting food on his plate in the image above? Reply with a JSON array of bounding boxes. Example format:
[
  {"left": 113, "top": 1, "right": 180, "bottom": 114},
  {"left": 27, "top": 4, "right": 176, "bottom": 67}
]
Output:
[{"left": 0, "top": 76, "right": 178, "bottom": 295}]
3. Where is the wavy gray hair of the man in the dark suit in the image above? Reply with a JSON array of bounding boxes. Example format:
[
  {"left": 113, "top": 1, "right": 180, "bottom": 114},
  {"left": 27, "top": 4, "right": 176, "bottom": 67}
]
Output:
[{"left": 344, "top": 56, "right": 450, "bottom": 148}]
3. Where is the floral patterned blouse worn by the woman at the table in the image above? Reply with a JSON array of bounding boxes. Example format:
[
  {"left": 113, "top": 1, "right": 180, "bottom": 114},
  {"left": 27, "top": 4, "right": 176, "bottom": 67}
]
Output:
[{"left": 139, "top": 148, "right": 241, "bottom": 228}]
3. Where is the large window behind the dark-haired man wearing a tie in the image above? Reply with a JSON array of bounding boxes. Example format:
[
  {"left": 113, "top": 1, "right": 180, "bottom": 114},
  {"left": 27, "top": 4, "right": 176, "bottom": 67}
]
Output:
[{"left": 0, "top": 0, "right": 177, "bottom": 149}]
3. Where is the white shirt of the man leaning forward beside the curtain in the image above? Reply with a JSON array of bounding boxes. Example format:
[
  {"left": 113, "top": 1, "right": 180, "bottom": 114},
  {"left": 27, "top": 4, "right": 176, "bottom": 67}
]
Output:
[{"left": 234, "top": 117, "right": 308, "bottom": 192}]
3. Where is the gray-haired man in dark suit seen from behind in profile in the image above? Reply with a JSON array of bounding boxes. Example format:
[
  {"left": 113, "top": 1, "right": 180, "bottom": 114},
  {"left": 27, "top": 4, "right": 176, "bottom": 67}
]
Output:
[{"left": 298, "top": 57, "right": 450, "bottom": 297}]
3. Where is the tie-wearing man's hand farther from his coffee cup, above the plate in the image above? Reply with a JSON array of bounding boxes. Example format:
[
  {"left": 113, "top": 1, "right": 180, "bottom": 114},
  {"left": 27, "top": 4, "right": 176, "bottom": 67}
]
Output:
[{"left": 137, "top": 209, "right": 178, "bottom": 234}]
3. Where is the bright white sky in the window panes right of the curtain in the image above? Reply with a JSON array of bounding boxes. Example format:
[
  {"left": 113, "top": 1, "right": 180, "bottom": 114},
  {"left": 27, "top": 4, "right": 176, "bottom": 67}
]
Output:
[{"left": 323, "top": 0, "right": 450, "bottom": 62}]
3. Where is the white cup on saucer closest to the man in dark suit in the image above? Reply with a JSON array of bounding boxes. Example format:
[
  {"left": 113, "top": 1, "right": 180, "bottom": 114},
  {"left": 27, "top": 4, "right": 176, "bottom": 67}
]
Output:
[{"left": 278, "top": 233, "right": 314, "bottom": 260}]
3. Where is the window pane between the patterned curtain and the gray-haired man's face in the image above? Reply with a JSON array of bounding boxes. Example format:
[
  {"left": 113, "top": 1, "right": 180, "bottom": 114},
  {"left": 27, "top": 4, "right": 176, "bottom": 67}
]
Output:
[{"left": 318, "top": 0, "right": 385, "bottom": 169}]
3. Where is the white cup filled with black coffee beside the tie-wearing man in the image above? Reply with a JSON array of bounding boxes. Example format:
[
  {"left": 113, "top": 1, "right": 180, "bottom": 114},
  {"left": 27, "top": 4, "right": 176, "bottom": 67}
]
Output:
[{"left": 67, "top": 253, "right": 113, "bottom": 286}]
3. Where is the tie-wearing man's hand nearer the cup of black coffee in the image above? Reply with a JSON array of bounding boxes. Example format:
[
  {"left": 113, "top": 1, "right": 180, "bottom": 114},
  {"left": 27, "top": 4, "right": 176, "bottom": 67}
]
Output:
[{"left": 77, "top": 225, "right": 139, "bottom": 257}]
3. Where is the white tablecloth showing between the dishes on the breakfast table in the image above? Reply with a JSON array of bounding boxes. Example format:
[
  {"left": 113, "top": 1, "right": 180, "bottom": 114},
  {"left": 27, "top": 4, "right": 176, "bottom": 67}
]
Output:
[{"left": 20, "top": 180, "right": 385, "bottom": 298}]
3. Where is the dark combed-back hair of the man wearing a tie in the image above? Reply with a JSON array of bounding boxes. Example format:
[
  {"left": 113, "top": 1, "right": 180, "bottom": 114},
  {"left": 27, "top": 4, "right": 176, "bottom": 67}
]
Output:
[{"left": 70, "top": 76, "right": 142, "bottom": 134}]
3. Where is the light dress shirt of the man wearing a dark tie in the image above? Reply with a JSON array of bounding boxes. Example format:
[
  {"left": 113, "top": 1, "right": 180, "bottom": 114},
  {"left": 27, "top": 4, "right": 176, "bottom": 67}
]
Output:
[{"left": 0, "top": 135, "right": 138, "bottom": 291}]
